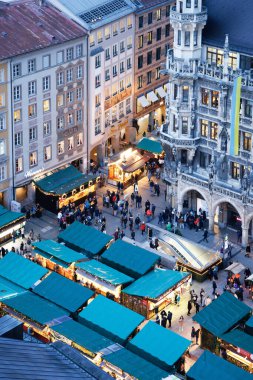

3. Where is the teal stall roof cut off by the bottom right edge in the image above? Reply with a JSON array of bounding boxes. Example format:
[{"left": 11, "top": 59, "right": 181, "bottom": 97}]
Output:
[{"left": 187, "top": 351, "right": 253, "bottom": 380}]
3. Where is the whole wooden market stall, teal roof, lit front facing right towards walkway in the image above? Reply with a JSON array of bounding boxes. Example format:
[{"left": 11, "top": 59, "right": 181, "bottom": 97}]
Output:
[{"left": 121, "top": 268, "right": 191, "bottom": 319}]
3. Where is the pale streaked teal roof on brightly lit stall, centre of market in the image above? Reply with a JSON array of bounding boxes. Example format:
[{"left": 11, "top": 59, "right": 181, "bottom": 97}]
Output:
[{"left": 75, "top": 260, "right": 134, "bottom": 286}]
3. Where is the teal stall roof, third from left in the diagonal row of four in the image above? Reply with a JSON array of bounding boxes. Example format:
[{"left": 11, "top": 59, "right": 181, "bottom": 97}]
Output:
[{"left": 79, "top": 295, "right": 145, "bottom": 343}]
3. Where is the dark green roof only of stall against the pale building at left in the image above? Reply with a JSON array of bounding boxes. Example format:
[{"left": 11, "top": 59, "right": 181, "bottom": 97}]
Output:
[{"left": 34, "top": 165, "right": 97, "bottom": 195}]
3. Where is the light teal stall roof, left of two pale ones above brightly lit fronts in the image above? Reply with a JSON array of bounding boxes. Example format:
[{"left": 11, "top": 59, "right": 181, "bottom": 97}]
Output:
[{"left": 33, "top": 240, "right": 85, "bottom": 266}]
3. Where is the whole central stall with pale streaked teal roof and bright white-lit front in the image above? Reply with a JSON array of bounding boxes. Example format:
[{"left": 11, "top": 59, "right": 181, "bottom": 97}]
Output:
[{"left": 75, "top": 260, "right": 134, "bottom": 301}]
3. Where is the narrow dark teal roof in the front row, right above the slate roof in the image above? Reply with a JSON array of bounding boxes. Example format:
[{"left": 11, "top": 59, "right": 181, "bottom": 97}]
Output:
[{"left": 52, "top": 319, "right": 115, "bottom": 354}]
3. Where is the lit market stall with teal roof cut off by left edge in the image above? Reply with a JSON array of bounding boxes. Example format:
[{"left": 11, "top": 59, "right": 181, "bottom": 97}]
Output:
[{"left": 0, "top": 205, "right": 25, "bottom": 243}]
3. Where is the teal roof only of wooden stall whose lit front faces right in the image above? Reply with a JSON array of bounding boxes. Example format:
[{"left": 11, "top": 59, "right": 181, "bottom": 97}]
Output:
[{"left": 123, "top": 269, "right": 189, "bottom": 299}]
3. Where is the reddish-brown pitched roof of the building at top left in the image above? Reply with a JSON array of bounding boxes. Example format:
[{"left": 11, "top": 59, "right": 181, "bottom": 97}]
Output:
[{"left": 0, "top": 0, "right": 87, "bottom": 60}]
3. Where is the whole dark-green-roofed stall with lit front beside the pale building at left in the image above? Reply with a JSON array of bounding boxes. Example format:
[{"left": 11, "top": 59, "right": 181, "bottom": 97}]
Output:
[{"left": 34, "top": 165, "right": 99, "bottom": 213}]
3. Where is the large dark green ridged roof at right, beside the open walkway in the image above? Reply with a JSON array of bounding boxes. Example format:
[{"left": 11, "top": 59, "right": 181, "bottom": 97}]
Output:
[{"left": 192, "top": 292, "right": 251, "bottom": 337}]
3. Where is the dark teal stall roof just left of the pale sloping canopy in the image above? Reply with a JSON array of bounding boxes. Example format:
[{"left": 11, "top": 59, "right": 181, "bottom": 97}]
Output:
[{"left": 101, "top": 240, "right": 160, "bottom": 278}]
